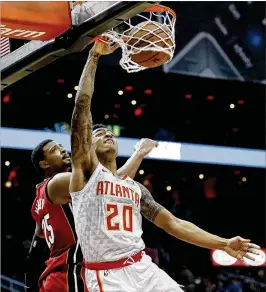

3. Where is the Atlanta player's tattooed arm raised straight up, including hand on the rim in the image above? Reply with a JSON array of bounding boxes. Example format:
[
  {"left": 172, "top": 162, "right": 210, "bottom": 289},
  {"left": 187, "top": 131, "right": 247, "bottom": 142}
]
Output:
[{"left": 70, "top": 42, "right": 116, "bottom": 192}]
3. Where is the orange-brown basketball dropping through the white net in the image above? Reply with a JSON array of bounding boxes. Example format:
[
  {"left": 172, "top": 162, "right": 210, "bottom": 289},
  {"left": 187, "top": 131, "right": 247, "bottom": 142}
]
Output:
[{"left": 128, "top": 21, "right": 173, "bottom": 68}]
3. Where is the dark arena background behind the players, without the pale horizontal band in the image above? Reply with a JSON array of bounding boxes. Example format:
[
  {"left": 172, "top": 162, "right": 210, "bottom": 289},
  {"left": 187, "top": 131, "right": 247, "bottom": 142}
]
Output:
[{"left": 1, "top": 2, "right": 265, "bottom": 291}]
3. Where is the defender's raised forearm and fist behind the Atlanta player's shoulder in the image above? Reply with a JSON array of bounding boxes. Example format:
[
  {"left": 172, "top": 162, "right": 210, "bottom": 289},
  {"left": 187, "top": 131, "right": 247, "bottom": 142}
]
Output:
[{"left": 117, "top": 138, "right": 158, "bottom": 178}]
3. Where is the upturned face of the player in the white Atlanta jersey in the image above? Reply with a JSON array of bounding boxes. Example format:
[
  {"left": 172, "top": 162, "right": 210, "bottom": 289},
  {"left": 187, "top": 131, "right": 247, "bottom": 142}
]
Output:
[{"left": 92, "top": 128, "right": 118, "bottom": 157}]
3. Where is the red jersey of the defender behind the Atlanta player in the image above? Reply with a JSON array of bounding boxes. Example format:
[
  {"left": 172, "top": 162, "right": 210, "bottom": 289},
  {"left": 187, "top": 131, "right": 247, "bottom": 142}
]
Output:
[{"left": 31, "top": 178, "right": 83, "bottom": 288}]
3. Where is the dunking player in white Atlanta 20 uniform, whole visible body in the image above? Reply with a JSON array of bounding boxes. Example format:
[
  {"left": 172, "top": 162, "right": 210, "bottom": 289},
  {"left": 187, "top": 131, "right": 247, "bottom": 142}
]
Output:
[{"left": 70, "top": 43, "right": 259, "bottom": 292}]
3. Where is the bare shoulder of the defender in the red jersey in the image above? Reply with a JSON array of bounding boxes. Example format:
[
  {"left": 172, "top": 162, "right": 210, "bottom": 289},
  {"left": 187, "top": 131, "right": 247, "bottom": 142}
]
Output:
[{"left": 47, "top": 172, "right": 71, "bottom": 205}]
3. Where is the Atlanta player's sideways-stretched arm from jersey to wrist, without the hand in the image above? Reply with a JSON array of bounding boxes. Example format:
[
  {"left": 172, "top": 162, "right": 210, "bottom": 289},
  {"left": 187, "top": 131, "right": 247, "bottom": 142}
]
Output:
[{"left": 139, "top": 184, "right": 228, "bottom": 249}]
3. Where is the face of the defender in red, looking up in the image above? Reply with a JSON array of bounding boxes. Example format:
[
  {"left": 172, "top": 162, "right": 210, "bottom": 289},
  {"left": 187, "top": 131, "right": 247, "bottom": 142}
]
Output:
[{"left": 43, "top": 141, "right": 71, "bottom": 172}]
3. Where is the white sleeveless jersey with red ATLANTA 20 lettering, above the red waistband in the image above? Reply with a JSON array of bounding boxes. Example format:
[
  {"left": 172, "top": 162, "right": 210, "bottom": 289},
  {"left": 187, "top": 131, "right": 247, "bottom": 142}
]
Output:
[{"left": 71, "top": 163, "right": 145, "bottom": 262}]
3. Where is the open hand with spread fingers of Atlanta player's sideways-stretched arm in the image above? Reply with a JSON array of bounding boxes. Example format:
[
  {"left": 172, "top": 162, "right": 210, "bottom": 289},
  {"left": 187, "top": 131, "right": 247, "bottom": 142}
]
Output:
[{"left": 224, "top": 236, "right": 260, "bottom": 265}]
